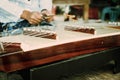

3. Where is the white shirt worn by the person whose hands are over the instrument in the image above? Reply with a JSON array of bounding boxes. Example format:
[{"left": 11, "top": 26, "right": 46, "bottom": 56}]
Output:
[{"left": 0, "top": 0, "right": 52, "bottom": 22}]
